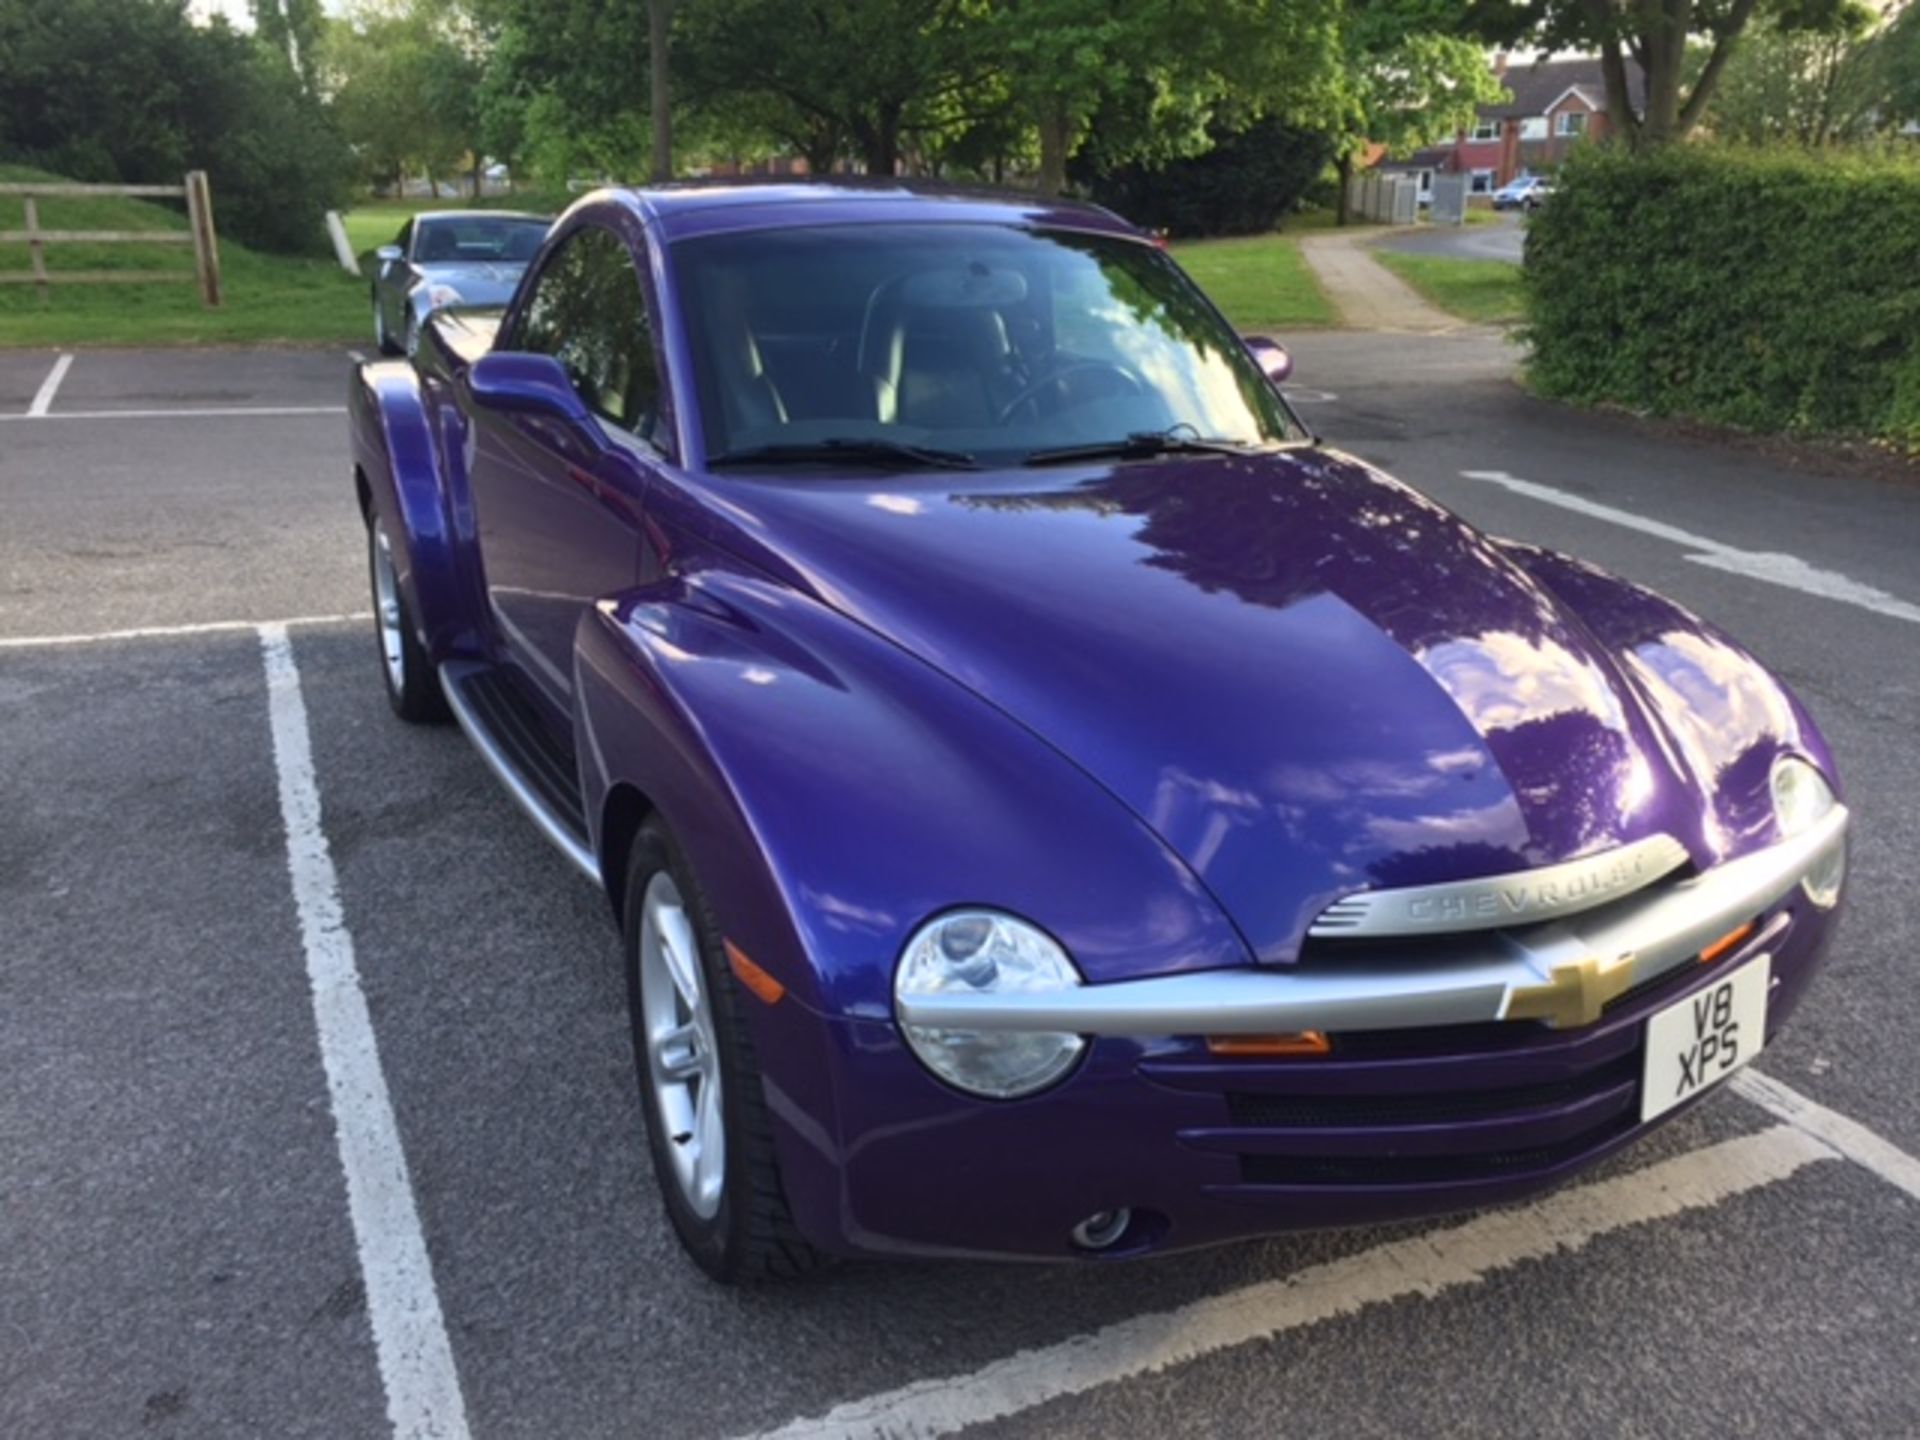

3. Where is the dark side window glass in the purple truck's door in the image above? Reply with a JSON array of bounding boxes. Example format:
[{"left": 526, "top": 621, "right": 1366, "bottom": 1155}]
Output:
[{"left": 515, "top": 227, "right": 660, "bottom": 442}]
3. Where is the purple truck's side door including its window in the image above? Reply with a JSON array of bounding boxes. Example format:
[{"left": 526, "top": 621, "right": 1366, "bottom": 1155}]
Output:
[{"left": 472, "top": 225, "right": 662, "bottom": 722}]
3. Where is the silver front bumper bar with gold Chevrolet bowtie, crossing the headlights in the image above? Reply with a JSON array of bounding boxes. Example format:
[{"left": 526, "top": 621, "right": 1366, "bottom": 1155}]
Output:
[{"left": 897, "top": 804, "right": 1849, "bottom": 1035}]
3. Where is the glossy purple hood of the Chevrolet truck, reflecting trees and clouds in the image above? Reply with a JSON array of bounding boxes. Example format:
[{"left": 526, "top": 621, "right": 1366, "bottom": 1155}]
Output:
[{"left": 710, "top": 447, "right": 1703, "bottom": 964}]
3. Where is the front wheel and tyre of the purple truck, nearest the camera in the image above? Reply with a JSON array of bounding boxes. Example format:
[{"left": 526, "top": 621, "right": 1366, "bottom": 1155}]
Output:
[{"left": 622, "top": 818, "right": 824, "bottom": 1283}]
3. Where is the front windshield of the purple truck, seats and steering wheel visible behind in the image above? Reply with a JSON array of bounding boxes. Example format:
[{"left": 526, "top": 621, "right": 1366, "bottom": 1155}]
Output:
[{"left": 674, "top": 225, "right": 1304, "bottom": 468}]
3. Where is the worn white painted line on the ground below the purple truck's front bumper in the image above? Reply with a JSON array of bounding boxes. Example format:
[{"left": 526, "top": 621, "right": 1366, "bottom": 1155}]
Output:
[{"left": 741, "top": 1125, "right": 1839, "bottom": 1440}]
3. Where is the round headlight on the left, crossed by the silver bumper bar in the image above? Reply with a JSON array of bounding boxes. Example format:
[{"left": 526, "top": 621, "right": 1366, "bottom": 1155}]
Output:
[{"left": 893, "top": 910, "right": 1087, "bottom": 1100}]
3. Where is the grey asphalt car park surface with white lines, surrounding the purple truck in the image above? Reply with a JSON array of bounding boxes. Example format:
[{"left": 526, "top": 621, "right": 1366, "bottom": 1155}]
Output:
[{"left": 0, "top": 334, "right": 1920, "bottom": 1436}]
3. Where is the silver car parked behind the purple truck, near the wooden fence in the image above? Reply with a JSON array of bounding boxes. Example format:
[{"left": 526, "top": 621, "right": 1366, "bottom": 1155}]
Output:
[{"left": 372, "top": 209, "right": 553, "bottom": 355}]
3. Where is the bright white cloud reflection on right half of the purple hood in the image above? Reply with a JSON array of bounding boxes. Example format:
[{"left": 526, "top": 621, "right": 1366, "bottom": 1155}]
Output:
[{"left": 1415, "top": 630, "right": 1626, "bottom": 735}]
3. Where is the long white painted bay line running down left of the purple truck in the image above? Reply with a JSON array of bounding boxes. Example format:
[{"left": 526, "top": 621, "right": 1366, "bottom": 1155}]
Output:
[{"left": 259, "top": 624, "right": 470, "bottom": 1440}]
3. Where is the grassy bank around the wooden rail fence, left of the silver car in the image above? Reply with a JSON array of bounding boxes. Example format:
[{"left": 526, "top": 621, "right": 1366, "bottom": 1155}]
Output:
[{"left": 0, "top": 165, "right": 371, "bottom": 346}]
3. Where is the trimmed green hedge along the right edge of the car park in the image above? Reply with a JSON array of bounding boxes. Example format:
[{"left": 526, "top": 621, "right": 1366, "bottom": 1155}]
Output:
[{"left": 1524, "top": 146, "right": 1920, "bottom": 451}]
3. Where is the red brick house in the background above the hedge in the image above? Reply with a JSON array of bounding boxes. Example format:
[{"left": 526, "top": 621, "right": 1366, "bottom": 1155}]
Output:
[{"left": 1379, "top": 56, "right": 1645, "bottom": 196}]
